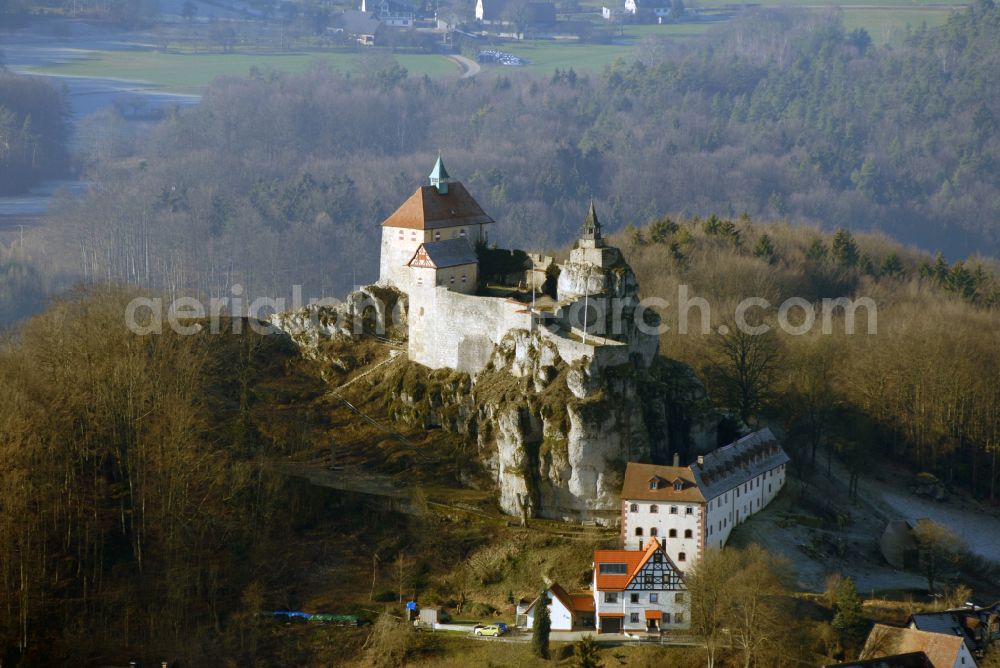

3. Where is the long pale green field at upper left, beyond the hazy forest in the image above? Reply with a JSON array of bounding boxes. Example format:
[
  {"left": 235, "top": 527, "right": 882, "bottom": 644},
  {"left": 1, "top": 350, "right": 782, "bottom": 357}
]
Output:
[{"left": 35, "top": 51, "right": 459, "bottom": 93}]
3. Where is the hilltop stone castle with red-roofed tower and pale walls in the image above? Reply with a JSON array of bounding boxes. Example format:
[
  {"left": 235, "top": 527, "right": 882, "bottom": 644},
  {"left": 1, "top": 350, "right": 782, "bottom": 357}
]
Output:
[{"left": 379, "top": 156, "right": 659, "bottom": 376}]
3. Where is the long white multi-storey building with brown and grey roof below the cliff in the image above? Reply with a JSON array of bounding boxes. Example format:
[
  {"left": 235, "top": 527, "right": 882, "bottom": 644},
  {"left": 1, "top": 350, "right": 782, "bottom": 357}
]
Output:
[{"left": 621, "top": 428, "right": 789, "bottom": 571}]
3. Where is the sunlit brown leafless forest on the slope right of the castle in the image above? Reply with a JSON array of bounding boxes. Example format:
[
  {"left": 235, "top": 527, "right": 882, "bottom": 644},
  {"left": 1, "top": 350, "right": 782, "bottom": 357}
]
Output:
[{"left": 619, "top": 216, "right": 1000, "bottom": 503}]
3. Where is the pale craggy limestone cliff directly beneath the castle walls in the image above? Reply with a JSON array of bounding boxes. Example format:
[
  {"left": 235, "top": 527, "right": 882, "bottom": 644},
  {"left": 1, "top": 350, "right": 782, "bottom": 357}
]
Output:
[{"left": 376, "top": 330, "right": 717, "bottom": 524}]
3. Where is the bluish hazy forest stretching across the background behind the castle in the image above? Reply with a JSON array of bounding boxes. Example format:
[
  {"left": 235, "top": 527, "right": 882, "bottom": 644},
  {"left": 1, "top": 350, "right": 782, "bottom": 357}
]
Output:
[{"left": 29, "top": 2, "right": 1000, "bottom": 306}]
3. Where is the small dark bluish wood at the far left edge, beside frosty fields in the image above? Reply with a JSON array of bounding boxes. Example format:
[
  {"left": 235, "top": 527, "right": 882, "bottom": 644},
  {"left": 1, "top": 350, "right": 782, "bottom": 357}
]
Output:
[{"left": 0, "top": 73, "right": 68, "bottom": 195}]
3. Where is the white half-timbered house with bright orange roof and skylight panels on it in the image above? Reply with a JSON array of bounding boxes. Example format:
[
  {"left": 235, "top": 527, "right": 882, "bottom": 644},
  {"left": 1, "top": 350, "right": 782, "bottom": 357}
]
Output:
[{"left": 592, "top": 538, "right": 690, "bottom": 633}]
